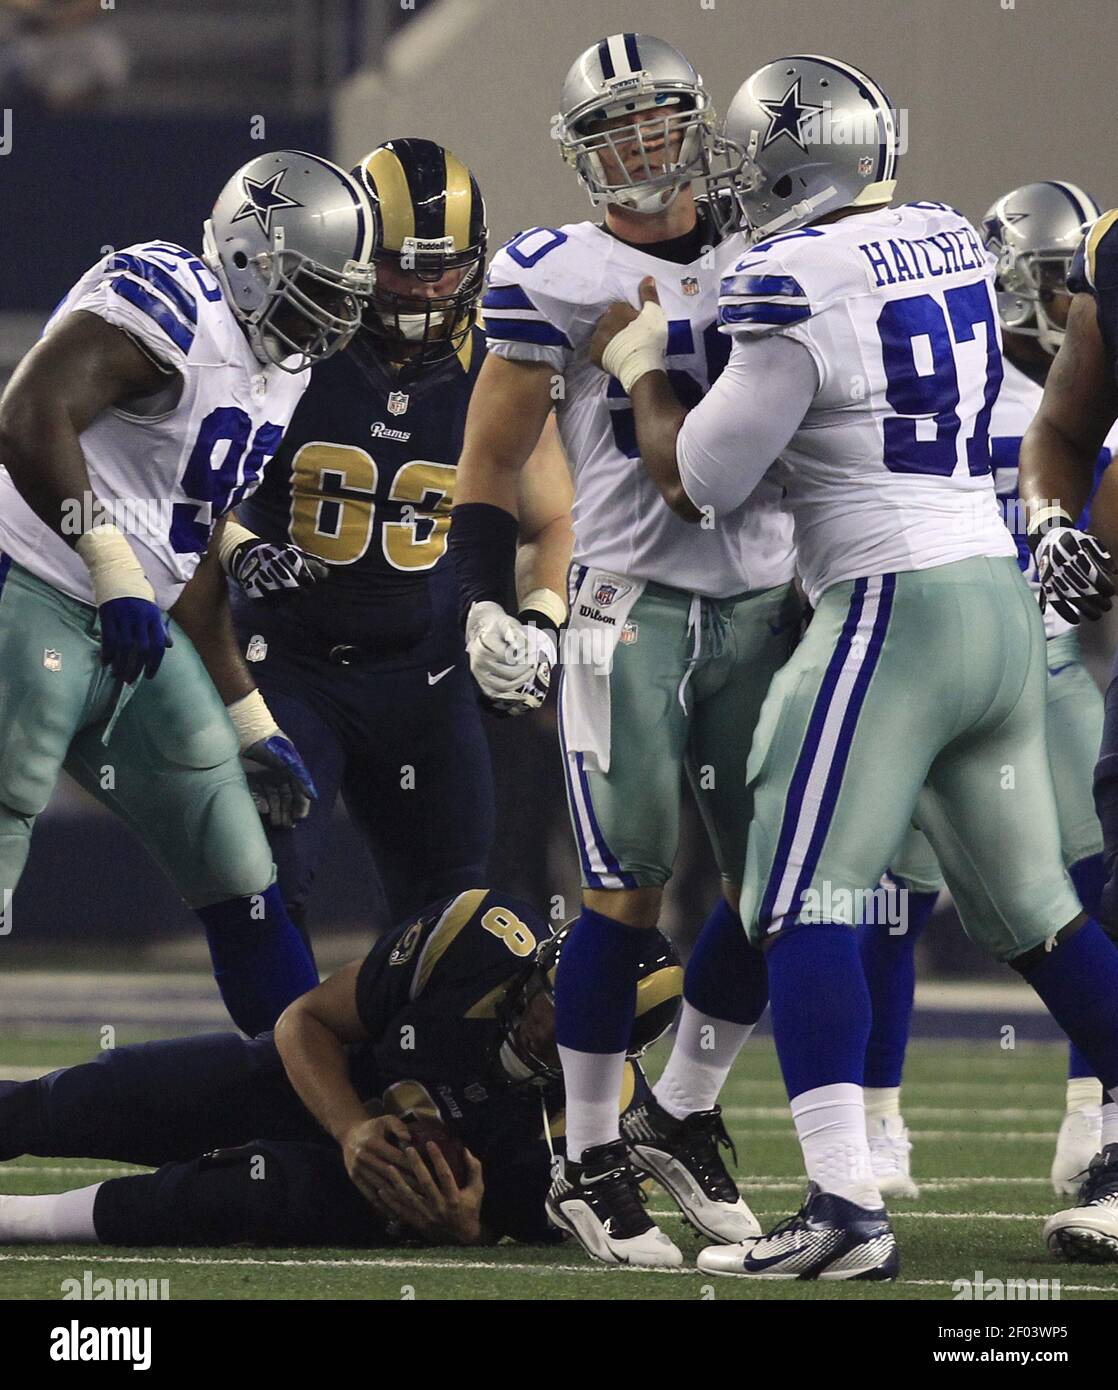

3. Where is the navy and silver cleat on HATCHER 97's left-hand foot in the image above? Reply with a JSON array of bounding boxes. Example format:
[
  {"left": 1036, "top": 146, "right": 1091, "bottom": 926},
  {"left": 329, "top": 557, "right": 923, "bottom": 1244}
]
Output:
[{"left": 698, "top": 1183, "right": 901, "bottom": 1279}]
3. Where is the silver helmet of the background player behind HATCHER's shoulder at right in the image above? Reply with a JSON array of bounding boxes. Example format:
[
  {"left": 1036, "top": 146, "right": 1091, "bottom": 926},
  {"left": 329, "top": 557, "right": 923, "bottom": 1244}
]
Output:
[{"left": 982, "top": 181, "right": 1101, "bottom": 356}]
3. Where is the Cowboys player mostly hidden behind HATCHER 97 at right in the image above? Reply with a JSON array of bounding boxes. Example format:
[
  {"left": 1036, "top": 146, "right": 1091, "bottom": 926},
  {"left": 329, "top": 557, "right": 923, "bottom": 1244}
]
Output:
[{"left": 859, "top": 182, "right": 1114, "bottom": 1197}]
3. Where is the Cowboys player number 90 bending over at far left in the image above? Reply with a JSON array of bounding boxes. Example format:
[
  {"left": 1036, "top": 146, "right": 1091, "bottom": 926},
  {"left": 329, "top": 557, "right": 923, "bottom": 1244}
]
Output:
[{"left": 0, "top": 150, "right": 373, "bottom": 1033}]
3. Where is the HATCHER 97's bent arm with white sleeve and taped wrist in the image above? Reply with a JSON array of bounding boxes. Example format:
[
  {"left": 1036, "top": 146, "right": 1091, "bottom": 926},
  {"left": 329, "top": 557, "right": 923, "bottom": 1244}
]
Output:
[{"left": 591, "top": 281, "right": 818, "bottom": 521}]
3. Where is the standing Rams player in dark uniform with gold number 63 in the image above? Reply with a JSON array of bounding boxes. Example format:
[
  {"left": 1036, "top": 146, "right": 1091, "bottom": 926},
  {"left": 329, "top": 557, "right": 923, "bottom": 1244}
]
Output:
[{"left": 216, "top": 139, "right": 570, "bottom": 927}]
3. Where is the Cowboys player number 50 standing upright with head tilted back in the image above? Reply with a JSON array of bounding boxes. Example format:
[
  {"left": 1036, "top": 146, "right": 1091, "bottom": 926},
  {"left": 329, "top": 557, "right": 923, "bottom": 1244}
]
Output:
[{"left": 451, "top": 33, "right": 801, "bottom": 1265}]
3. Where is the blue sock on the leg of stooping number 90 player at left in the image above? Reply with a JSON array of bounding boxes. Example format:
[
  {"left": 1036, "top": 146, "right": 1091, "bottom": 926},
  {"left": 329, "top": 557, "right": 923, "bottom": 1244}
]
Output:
[{"left": 197, "top": 884, "right": 318, "bottom": 1037}]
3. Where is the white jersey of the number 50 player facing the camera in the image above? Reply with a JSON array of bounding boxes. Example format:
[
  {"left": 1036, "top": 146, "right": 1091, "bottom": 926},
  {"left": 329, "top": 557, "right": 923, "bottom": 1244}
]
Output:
[{"left": 484, "top": 214, "right": 794, "bottom": 598}]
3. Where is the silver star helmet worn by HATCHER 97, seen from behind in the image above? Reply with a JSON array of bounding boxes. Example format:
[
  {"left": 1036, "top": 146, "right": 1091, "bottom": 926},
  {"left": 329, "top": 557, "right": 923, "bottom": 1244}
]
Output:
[{"left": 726, "top": 54, "right": 898, "bottom": 239}]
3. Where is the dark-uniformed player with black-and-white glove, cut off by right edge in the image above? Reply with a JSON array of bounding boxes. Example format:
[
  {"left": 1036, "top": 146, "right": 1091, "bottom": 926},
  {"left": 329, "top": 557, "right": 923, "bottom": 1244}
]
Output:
[{"left": 1021, "top": 202, "right": 1118, "bottom": 1261}]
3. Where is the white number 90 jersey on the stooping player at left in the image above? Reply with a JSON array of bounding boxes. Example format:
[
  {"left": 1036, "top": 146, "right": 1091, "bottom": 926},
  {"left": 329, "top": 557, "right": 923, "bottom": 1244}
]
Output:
[{"left": 0, "top": 242, "right": 310, "bottom": 609}]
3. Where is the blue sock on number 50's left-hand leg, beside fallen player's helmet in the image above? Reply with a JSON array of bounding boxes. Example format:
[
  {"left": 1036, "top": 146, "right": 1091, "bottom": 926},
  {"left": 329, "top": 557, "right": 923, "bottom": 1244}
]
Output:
[{"left": 555, "top": 908, "right": 651, "bottom": 1052}]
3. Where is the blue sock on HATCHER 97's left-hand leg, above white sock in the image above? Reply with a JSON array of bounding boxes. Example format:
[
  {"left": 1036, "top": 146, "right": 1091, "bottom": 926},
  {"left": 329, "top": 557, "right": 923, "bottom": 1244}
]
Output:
[{"left": 769, "top": 922, "right": 869, "bottom": 1099}]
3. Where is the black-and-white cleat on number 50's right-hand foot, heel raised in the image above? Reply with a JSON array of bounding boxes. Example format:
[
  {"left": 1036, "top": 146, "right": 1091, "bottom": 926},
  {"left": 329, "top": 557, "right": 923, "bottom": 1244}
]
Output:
[{"left": 622, "top": 1097, "right": 761, "bottom": 1245}]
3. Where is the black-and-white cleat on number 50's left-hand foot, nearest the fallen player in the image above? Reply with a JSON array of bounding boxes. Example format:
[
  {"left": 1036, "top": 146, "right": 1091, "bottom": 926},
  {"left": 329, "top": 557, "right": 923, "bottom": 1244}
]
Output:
[{"left": 546, "top": 1140, "right": 683, "bottom": 1269}]
